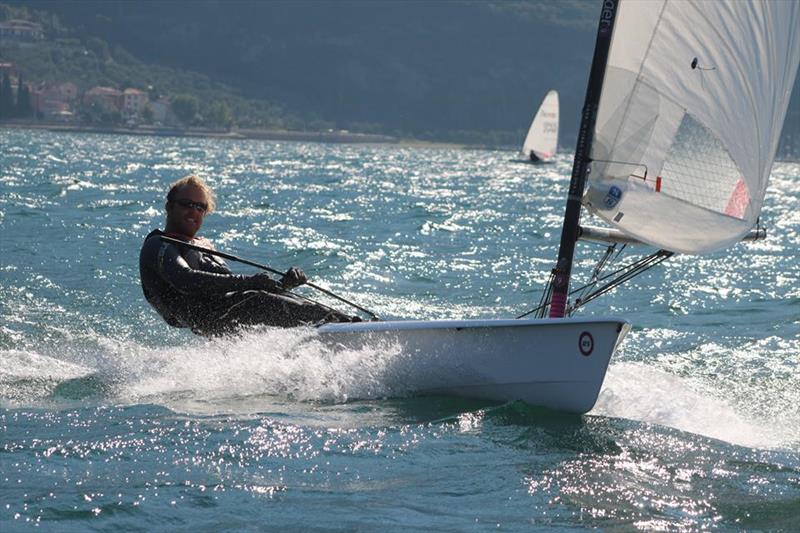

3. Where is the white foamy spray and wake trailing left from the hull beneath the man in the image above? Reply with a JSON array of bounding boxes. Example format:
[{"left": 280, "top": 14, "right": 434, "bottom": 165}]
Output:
[{"left": 0, "top": 328, "right": 425, "bottom": 413}]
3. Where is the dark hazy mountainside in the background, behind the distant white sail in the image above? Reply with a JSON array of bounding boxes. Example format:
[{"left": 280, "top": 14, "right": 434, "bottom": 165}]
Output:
[{"left": 0, "top": 0, "right": 800, "bottom": 153}]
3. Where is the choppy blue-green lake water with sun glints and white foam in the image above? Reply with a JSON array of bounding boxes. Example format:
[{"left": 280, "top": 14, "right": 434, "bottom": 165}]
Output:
[{"left": 0, "top": 130, "right": 800, "bottom": 531}]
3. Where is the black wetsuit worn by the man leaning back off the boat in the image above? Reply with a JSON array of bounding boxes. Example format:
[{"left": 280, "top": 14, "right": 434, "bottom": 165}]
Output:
[{"left": 139, "top": 230, "right": 359, "bottom": 335}]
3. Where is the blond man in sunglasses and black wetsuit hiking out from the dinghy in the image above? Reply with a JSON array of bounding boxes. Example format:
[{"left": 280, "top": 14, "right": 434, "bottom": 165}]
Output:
[{"left": 139, "top": 176, "right": 361, "bottom": 336}]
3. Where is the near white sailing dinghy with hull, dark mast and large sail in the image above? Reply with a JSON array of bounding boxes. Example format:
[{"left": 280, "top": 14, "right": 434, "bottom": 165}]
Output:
[{"left": 319, "top": 0, "right": 800, "bottom": 413}]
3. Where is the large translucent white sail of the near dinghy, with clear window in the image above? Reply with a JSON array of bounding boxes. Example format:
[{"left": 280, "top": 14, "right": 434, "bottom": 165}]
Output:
[{"left": 583, "top": 0, "right": 800, "bottom": 253}]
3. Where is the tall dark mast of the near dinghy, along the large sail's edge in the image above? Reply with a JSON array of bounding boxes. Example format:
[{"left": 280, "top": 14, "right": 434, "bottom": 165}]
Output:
[{"left": 550, "top": 0, "right": 621, "bottom": 318}]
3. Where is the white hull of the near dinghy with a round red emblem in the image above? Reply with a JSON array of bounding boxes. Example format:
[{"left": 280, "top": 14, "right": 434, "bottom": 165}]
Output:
[{"left": 319, "top": 318, "right": 630, "bottom": 413}]
